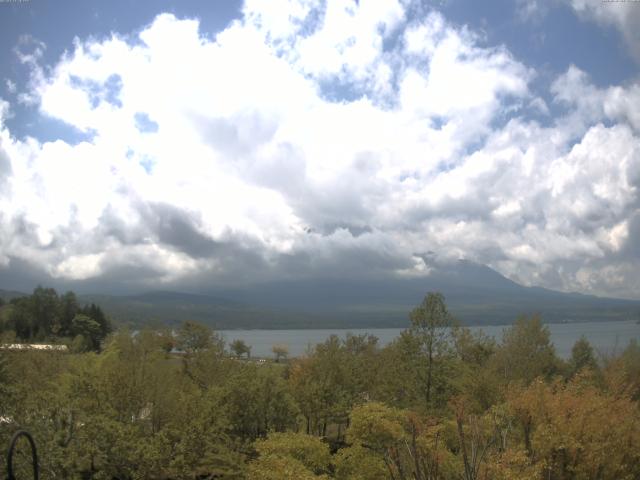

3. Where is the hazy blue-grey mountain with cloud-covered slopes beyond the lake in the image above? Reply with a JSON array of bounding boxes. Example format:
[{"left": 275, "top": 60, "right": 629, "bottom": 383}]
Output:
[{"left": 80, "top": 261, "right": 640, "bottom": 328}]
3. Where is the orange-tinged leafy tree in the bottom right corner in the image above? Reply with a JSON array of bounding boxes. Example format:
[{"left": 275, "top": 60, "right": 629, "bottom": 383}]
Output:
[{"left": 508, "top": 374, "right": 640, "bottom": 479}]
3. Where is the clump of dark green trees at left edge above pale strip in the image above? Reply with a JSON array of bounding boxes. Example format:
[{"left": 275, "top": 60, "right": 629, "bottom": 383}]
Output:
[{"left": 0, "top": 286, "right": 112, "bottom": 352}]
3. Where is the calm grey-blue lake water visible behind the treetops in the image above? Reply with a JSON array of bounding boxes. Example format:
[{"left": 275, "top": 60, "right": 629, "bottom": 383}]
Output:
[{"left": 220, "top": 321, "right": 640, "bottom": 358}]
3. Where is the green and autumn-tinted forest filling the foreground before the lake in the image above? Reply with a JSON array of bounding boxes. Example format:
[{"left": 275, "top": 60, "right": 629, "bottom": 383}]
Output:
[{"left": 0, "top": 289, "right": 640, "bottom": 480}]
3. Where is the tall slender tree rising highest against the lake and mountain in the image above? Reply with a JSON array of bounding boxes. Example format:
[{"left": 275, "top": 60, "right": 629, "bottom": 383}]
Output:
[{"left": 410, "top": 292, "right": 453, "bottom": 404}]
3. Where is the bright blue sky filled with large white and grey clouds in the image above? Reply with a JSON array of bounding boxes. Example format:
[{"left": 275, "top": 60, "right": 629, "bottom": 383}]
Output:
[{"left": 0, "top": 0, "right": 640, "bottom": 299}]
